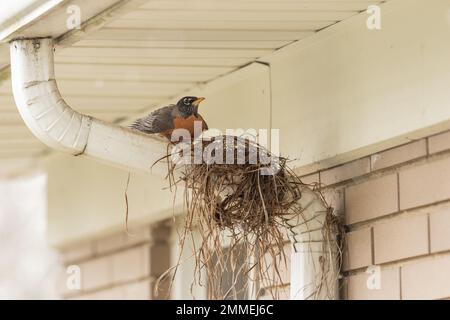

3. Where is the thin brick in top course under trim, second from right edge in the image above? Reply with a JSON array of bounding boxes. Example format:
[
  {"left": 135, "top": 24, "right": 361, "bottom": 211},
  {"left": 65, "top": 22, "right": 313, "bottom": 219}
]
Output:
[{"left": 371, "top": 139, "right": 427, "bottom": 170}]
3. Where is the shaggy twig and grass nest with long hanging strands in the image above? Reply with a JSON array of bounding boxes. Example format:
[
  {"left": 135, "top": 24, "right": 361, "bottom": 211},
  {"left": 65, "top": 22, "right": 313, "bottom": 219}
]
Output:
[{"left": 155, "top": 136, "right": 342, "bottom": 299}]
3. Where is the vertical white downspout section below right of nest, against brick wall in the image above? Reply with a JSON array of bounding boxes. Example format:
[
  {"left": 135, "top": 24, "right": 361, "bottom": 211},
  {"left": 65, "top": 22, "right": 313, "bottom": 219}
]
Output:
[{"left": 285, "top": 187, "right": 339, "bottom": 300}]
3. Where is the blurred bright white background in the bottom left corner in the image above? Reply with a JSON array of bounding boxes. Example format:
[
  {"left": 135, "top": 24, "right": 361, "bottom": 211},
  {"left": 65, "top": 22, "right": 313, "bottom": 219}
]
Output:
[{"left": 0, "top": 172, "right": 59, "bottom": 300}]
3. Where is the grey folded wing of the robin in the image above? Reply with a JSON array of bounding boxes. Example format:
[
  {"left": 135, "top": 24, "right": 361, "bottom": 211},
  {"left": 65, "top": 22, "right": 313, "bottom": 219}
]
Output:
[{"left": 131, "top": 105, "right": 175, "bottom": 133}]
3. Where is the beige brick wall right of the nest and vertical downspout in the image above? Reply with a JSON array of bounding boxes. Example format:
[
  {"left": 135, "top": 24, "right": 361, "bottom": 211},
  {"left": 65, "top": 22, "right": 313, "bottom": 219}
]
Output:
[{"left": 265, "top": 127, "right": 450, "bottom": 300}]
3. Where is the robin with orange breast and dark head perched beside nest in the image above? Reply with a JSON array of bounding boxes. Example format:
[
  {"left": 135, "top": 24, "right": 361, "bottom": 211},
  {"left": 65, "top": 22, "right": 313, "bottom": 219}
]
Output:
[{"left": 131, "top": 96, "right": 208, "bottom": 140}]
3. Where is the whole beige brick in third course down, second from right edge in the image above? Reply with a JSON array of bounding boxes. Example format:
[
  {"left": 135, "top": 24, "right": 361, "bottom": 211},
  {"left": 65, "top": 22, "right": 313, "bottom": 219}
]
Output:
[{"left": 374, "top": 214, "right": 428, "bottom": 264}]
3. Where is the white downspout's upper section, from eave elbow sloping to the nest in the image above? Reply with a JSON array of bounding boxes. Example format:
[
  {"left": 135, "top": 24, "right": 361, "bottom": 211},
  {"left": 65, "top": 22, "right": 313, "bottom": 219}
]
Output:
[{"left": 10, "top": 38, "right": 166, "bottom": 173}]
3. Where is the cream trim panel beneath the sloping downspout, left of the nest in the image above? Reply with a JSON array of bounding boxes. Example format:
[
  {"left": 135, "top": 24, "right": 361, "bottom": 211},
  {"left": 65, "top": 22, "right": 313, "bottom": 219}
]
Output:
[{"left": 45, "top": 154, "right": 180, "bottom": 247}]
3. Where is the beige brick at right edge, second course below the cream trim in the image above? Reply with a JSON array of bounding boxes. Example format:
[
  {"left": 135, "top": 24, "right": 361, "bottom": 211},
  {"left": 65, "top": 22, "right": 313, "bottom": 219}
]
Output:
[{"left": 400, "top": 158, "right": 450, "bottom": 209}]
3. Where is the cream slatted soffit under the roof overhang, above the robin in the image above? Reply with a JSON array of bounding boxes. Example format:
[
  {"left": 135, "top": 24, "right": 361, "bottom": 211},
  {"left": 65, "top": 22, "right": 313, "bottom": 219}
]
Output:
[{"left": 0, "top": 0, "right": 383, "bottom": 174}]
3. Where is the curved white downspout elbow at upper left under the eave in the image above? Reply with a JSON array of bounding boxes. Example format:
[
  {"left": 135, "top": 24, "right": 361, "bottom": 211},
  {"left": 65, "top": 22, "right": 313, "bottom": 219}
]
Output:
[{"left": 10, "top": 38, "right": 92, "bottom": 155}]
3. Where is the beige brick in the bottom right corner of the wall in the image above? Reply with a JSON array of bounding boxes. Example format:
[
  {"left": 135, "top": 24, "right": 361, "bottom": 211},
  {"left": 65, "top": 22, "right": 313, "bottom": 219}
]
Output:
[{"left": 402, "top": 255, "right": 450, "bottom": 300}]
